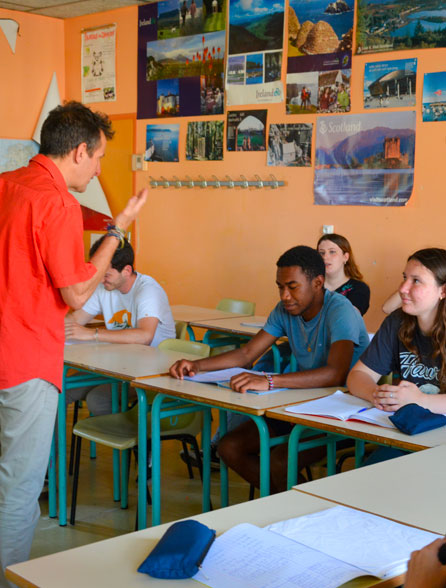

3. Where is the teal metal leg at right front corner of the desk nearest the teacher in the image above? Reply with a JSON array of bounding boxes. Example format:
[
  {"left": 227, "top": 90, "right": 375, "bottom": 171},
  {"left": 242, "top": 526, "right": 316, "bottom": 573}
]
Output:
[{"left": 135, "top": 388, "right": 149, "bottom": 530}]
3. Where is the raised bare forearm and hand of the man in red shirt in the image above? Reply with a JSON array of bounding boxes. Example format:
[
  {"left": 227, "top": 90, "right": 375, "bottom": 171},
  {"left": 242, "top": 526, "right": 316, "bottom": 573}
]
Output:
[{"left": 60, "top": 188, "right": 148, "bottom": 310}]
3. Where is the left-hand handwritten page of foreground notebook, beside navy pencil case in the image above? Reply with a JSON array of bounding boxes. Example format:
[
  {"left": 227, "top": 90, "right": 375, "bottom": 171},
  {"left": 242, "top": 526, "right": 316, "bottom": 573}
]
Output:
[{"left": 194, "top": 523, "right": 366, "bottom": 588}]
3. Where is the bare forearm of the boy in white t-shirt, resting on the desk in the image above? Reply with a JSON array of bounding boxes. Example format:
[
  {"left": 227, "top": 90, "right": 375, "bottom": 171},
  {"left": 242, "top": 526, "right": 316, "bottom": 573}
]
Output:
[{"left": 65, "top": 310, "right": 159, "bottom": 345}]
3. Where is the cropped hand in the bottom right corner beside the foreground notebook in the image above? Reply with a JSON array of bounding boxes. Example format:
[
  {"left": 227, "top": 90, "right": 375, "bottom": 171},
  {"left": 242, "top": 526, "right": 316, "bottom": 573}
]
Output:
[{"left": 404, "top": 539, "right": 446, "bottom": 588}]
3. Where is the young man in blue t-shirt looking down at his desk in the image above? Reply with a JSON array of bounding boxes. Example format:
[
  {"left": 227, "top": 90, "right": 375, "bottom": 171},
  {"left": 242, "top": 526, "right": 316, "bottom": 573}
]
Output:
[{"left": 170, "top": 245, "right": 369, "bottom": 492}]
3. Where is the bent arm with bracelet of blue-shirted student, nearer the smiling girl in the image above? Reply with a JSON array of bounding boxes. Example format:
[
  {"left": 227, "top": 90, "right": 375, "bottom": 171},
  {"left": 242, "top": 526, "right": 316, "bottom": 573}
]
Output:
[{"left": 231, "top": 341, "right": 353, "bottom": 392}]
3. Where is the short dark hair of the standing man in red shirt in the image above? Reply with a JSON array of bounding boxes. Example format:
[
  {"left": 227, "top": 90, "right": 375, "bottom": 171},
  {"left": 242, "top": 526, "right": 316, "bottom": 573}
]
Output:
[{"left": 40, "top": 101, "right": 114, "bottom": 157}]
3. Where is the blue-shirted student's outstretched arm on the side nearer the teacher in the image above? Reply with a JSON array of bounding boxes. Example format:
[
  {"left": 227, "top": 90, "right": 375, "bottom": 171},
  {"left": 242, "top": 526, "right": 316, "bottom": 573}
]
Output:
[{"left": 170, "top": 329, "right": 277, "bottom": 381}]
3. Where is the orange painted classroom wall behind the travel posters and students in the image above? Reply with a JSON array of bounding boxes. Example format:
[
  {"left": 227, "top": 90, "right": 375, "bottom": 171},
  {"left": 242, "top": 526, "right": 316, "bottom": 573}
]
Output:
[{"left": 0, "top": 7, "right": 446, "bottom": 331}]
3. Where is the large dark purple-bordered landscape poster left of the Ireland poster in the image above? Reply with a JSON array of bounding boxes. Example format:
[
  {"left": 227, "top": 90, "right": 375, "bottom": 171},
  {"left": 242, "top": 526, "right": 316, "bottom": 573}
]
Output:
[{"left": 137, "top": 0, "right": 226, "bottom": 118}]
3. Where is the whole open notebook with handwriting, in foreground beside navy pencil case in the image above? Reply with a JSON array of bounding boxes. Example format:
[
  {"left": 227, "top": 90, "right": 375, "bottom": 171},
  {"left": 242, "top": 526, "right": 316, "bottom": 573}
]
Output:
[{"left": 194, "top": 506, "right": 438, "bottom": 588}]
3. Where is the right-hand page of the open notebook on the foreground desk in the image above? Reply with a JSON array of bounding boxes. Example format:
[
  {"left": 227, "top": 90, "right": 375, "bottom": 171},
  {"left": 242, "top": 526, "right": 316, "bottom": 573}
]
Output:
[{"left": 267, "top": 506, "right": 439, "bottom": 578}]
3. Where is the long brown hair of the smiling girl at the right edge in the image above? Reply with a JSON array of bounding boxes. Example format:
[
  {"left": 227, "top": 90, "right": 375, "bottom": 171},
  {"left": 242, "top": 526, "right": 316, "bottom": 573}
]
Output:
[{"left": 398, "top": 247, "right": 446, "bottom": 392}]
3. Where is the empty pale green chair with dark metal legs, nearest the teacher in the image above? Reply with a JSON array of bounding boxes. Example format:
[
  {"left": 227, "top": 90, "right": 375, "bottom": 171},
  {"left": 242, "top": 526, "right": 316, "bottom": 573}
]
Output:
[{"left": 70, "top": 339, "right": 210, "bottom": 525}]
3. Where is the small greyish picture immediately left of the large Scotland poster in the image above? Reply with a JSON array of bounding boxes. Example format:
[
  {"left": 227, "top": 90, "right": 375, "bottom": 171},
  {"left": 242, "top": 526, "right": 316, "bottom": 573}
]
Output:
[{"left": 267, "top": 124, "right": 313, "bottom": 167}]
